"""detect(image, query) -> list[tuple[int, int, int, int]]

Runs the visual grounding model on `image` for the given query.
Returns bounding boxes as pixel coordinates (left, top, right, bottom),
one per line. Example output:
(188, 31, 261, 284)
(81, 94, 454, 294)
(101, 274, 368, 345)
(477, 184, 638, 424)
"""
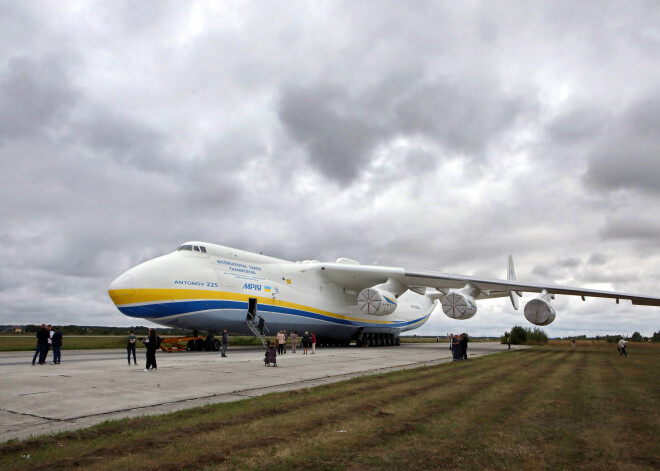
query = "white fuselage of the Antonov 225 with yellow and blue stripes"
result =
(109, 242, 436, 339)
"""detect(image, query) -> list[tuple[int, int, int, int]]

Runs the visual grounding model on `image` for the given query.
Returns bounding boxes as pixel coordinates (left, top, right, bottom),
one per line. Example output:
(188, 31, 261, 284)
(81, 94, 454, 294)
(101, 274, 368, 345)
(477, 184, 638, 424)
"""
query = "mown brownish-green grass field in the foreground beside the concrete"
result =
(0, 344, 660, 471)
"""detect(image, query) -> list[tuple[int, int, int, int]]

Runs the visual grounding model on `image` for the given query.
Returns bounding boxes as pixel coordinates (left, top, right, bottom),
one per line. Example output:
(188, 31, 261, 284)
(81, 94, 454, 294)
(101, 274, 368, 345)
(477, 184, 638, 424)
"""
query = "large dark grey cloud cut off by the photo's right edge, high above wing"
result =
(584, 88, 660, 194)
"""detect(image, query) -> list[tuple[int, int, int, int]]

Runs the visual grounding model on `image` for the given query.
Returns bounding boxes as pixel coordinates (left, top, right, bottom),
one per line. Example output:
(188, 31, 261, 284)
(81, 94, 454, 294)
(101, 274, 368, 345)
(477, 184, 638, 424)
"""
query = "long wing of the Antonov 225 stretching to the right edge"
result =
(320, 263, 660, 306)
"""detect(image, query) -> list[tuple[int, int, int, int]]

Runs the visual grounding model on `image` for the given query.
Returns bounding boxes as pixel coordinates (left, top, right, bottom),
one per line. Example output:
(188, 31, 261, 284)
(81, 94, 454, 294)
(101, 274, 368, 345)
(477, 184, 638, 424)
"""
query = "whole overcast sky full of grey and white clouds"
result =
(0, 0, 660, 336)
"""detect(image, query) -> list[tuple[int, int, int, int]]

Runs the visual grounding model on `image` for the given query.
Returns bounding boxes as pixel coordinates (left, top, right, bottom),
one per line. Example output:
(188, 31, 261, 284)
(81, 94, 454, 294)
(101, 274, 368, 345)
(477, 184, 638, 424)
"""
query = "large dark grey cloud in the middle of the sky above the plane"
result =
(278, 78, 536, 184)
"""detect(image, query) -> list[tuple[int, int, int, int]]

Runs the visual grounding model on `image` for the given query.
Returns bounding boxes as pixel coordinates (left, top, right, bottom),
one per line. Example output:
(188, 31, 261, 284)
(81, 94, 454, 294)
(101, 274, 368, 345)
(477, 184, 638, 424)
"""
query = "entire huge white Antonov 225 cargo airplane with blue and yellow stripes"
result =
(108, 241, 660, 346)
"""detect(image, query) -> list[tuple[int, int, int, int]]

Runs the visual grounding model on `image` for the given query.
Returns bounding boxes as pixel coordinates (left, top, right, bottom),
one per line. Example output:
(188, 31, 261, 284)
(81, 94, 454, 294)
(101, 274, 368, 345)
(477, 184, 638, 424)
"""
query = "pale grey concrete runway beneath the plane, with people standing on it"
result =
(0, 342, 521, 442)
